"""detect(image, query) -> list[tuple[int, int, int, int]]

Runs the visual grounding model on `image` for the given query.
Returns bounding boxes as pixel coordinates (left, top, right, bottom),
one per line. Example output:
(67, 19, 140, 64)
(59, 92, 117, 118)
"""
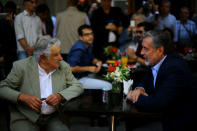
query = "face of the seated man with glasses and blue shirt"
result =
(79, 28, 94, 45)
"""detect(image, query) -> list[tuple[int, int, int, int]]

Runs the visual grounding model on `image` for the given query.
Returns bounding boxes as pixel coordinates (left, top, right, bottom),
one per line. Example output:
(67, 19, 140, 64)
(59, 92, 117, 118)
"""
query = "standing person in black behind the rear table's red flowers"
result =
(91, 0, 124, 61)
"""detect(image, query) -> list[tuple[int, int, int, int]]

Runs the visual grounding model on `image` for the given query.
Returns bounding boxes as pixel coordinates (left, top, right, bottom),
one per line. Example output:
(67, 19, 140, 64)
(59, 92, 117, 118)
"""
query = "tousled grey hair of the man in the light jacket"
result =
(33, 35, 61, 62)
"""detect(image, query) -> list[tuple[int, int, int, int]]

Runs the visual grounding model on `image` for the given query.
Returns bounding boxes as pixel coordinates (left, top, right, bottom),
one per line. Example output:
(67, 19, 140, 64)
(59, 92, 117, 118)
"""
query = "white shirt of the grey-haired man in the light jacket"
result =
(38, 64, 55, 115)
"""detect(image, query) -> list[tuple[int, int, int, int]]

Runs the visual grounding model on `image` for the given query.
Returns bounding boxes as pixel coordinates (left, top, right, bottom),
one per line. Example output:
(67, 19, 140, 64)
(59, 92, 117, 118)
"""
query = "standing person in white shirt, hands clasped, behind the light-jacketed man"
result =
(14, 0, 42, 59)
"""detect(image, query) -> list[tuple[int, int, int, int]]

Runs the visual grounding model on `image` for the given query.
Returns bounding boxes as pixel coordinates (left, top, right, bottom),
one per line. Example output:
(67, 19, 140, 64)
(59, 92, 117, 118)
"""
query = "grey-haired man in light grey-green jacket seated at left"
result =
(0, 36, 83, 131)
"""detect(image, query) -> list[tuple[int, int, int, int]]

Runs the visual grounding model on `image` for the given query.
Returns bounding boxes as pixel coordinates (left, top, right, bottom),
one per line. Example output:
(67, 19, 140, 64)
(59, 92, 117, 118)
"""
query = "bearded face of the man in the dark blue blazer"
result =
(141, 36, 164, 66)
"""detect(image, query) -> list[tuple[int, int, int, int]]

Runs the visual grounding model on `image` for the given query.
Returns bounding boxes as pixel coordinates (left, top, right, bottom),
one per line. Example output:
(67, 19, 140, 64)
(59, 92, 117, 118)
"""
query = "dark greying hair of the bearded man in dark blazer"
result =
(142, 31, 173, 55)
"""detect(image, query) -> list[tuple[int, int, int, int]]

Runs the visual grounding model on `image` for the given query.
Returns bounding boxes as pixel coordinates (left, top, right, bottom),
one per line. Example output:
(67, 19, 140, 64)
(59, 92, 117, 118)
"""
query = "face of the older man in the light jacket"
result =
(46, 45, 62, 69)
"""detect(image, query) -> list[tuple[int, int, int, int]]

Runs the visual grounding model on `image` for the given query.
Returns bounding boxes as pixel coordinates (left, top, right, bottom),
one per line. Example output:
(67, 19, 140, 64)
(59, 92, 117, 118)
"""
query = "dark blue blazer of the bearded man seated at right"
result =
(136, 53, 197, 131)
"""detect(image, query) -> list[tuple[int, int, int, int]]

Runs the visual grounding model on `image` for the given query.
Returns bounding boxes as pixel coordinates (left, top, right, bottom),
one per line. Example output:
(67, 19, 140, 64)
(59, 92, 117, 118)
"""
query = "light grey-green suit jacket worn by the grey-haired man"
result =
(0, 57, 83, 124)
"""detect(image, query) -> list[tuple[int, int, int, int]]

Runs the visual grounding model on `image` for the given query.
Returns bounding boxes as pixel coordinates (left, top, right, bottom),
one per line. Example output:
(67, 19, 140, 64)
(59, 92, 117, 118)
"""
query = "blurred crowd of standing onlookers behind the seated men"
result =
(0, 0, 197, 78)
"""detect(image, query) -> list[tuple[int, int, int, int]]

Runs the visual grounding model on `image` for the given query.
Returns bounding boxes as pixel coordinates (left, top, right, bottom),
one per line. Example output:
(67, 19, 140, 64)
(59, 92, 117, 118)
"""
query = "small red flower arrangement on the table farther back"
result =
(104, 46, 120, 60)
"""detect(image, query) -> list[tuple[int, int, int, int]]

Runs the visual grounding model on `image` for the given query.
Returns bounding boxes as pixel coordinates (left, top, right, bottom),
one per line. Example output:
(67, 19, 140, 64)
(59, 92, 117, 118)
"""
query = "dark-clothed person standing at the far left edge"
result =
(0, 1, 17, 76)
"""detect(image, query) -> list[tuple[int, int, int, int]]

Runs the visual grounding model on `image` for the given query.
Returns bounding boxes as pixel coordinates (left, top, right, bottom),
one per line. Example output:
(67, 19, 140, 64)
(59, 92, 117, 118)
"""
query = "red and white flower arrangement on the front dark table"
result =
(104, 61, 130, 92)
